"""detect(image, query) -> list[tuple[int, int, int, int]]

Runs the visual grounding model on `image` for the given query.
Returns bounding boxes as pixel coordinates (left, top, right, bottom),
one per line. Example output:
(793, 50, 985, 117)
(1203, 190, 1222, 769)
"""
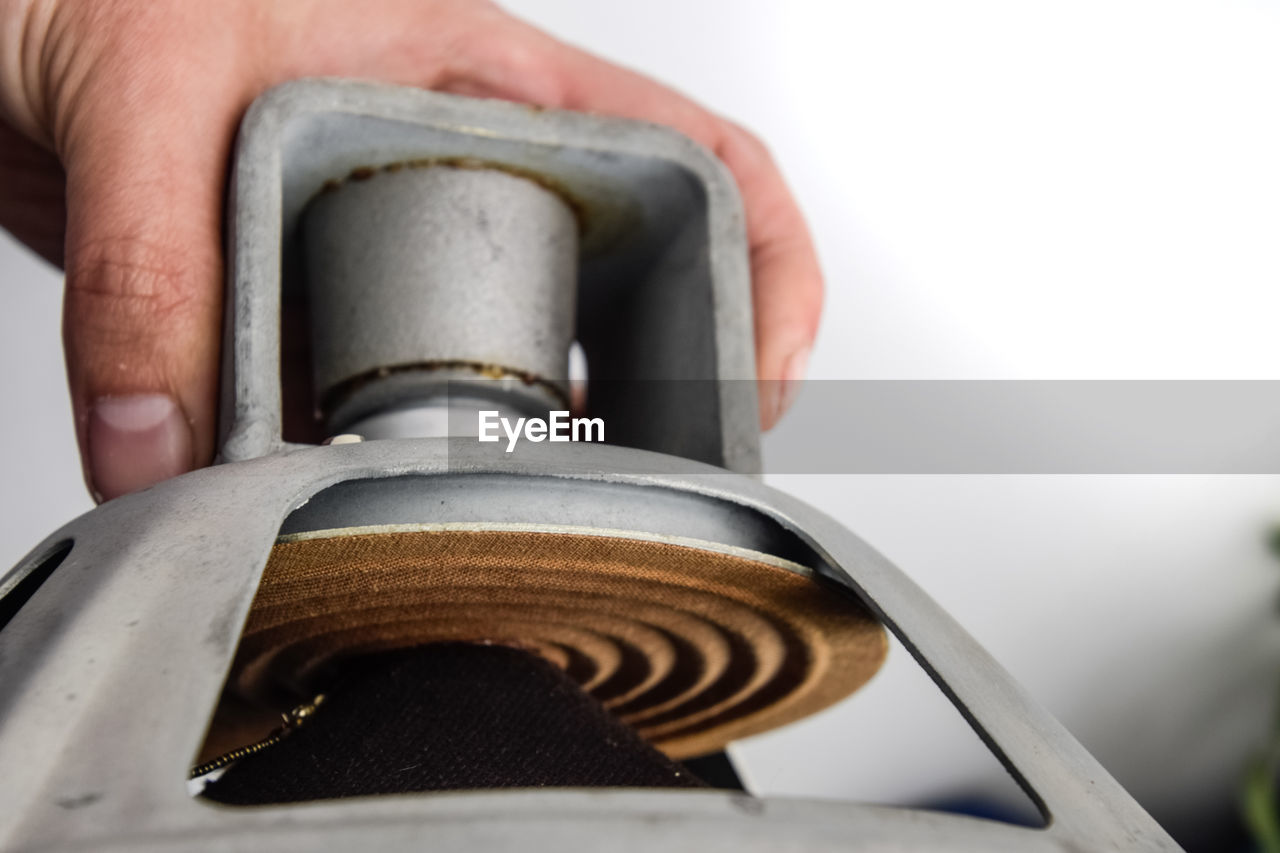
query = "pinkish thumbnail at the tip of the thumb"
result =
(88, 394, 191, 500)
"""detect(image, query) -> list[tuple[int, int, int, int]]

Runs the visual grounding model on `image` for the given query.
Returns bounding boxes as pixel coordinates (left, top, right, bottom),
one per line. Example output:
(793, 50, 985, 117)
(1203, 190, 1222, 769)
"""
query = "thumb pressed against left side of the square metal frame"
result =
(59, 80, 230, 500)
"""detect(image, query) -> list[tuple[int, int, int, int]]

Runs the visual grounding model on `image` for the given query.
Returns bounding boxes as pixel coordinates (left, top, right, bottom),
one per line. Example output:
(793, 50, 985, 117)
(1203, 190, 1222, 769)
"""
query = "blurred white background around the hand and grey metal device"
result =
(0, 0, 1280, 838)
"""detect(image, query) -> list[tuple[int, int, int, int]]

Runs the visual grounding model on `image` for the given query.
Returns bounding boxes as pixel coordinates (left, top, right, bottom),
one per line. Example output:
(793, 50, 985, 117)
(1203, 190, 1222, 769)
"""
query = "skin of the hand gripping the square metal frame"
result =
(0, 0, 823, 500)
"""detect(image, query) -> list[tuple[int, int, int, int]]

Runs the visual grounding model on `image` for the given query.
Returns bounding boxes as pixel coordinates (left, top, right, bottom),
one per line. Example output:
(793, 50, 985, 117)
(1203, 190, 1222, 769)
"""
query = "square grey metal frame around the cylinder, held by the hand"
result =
(220, 79, 759, 473)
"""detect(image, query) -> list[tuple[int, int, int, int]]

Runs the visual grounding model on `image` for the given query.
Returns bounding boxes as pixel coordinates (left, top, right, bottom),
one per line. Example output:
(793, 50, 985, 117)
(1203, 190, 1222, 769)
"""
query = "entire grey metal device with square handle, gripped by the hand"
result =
(0, 81, 1178, 852)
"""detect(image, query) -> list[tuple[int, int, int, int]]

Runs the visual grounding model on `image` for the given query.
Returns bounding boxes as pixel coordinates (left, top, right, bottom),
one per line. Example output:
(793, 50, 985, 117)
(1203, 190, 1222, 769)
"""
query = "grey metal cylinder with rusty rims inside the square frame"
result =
(302, 165, 577, 432)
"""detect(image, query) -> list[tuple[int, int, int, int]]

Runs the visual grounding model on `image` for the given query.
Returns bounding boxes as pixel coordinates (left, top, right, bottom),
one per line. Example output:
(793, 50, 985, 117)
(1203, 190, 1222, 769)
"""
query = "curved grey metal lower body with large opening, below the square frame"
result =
(0, 439, 1176, 850)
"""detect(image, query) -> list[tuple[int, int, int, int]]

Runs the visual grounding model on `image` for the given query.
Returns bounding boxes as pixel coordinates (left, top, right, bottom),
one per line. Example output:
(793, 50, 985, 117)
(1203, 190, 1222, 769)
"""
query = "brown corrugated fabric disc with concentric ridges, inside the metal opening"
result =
(220, 528, 886, 760)
